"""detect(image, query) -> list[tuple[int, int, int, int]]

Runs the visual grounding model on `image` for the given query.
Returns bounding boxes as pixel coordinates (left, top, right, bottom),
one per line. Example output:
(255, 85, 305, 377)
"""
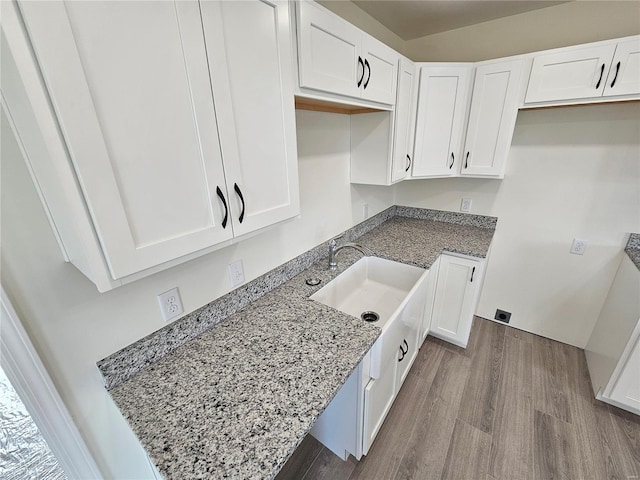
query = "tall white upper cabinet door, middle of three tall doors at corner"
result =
(411, 64, 473, 178)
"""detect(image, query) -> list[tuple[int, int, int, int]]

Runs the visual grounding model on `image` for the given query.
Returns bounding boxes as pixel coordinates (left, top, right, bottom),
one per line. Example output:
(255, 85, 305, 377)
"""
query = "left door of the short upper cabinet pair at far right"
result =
(525, 45, 615, 103)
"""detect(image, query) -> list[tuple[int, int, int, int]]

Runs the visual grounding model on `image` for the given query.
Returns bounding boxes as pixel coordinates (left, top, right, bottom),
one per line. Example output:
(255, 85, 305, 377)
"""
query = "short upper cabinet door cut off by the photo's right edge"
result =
(604, 38, 640, 97)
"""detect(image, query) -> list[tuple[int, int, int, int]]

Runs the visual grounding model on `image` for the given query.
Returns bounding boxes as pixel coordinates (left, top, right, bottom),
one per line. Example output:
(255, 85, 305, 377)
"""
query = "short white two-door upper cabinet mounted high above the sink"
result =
(296, 1, 400, 105)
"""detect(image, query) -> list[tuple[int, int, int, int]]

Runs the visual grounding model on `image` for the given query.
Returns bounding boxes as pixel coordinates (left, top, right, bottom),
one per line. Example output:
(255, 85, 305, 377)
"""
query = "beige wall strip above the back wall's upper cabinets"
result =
(404, 0, 640, 62)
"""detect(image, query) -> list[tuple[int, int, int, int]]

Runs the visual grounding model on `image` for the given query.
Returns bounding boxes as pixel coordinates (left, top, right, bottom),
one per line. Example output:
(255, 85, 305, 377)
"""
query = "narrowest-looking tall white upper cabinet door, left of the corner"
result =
(391, 59, 415, 183)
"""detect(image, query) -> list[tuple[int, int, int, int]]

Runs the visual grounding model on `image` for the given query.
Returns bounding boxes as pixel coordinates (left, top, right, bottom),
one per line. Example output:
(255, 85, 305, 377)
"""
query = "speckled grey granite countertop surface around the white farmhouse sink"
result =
(103, 207, 495, 480)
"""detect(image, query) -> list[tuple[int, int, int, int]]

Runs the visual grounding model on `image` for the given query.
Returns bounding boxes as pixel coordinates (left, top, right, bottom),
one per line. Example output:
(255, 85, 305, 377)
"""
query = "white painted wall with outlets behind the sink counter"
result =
(0, 111, 393, 478)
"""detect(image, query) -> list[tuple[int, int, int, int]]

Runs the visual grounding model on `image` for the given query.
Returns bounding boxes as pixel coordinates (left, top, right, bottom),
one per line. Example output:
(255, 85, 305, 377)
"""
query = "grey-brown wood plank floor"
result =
(276, 317, 640, 480)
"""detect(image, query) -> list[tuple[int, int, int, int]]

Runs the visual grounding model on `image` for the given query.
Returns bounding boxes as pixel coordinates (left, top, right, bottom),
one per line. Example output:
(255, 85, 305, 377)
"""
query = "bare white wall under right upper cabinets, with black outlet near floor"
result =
(396, 103, 640, 348)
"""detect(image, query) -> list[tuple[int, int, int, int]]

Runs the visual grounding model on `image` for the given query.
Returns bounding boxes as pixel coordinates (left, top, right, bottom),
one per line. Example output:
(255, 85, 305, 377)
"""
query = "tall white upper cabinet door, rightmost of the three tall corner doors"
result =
(460, 60, 524, 178)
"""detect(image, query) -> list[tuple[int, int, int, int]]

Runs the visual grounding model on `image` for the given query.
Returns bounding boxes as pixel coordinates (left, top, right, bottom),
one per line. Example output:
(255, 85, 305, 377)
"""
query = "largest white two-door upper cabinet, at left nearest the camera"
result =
(19, 0, 299, 291)
